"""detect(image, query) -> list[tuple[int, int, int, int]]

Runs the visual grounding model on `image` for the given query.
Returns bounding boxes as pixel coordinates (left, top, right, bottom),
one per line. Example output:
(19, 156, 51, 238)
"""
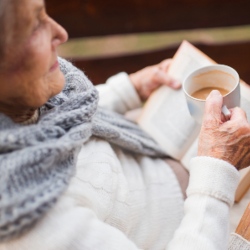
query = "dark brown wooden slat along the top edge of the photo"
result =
(46, 0, 250, 38)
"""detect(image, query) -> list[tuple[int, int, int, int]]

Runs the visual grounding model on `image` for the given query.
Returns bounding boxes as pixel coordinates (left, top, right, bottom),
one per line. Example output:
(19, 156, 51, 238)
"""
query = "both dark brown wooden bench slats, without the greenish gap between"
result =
(46, 0, 250, 84)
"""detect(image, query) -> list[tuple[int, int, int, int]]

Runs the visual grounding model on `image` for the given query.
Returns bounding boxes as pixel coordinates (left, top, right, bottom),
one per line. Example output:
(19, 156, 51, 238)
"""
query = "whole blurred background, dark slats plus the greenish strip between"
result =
(46, 0, 250, 84)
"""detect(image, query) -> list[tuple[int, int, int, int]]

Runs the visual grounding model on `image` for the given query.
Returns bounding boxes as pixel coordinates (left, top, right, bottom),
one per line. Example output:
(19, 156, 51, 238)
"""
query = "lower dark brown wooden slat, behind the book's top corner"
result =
(69, 41, 250, 84)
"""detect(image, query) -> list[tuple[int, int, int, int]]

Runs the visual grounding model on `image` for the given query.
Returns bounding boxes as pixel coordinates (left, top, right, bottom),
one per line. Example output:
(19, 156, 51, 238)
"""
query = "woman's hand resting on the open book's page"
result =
(130, 59, 181, 101)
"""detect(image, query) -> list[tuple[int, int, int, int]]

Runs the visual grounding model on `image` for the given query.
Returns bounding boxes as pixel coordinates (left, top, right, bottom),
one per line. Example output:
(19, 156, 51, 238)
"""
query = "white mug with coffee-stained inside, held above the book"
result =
(183, 64, 240, 123)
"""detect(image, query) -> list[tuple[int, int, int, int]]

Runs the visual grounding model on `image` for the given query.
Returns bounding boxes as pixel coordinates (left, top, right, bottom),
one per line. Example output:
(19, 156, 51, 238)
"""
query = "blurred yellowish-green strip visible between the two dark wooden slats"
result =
(59, 25, 250, 61)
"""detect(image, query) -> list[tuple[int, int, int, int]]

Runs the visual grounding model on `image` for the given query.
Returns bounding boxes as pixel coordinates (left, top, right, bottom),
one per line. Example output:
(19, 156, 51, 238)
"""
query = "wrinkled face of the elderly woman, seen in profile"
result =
(0, 0, 67, 111)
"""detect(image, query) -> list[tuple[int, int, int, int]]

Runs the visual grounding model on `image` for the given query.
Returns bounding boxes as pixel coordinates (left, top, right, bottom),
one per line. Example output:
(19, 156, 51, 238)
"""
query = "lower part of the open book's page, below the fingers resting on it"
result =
(138, 87, 200, 160)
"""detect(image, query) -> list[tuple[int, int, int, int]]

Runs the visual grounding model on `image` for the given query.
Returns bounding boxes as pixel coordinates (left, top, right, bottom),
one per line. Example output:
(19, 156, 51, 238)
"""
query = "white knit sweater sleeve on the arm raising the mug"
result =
(167, 157, 239, 250)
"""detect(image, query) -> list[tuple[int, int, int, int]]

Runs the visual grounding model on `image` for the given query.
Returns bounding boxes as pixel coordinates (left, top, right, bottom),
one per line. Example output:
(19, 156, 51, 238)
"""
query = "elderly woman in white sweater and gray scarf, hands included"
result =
(0, 0, 250, 250)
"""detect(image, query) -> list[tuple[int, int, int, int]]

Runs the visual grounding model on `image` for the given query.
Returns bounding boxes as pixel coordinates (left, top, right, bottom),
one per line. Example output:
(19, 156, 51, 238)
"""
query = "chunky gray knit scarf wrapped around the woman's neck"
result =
(0, 58, 165, 240)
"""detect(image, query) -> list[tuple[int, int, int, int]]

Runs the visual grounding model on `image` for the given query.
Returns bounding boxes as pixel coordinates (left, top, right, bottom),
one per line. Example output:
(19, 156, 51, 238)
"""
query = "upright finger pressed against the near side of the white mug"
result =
(204, 90, 223, 121)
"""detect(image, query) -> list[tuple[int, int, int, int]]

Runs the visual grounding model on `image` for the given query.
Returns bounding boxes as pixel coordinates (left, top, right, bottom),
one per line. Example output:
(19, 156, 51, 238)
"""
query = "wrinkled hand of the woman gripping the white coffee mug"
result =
(198, 90, 250, 170)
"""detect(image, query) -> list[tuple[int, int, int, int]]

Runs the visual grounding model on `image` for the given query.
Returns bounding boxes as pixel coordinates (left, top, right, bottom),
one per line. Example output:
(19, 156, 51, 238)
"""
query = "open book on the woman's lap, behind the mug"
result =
(137, 41, 250, 201)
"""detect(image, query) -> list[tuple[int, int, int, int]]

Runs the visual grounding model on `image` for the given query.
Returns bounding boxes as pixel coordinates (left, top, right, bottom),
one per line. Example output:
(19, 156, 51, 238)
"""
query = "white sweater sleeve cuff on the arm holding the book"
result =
(97, 72, 141, 114)
